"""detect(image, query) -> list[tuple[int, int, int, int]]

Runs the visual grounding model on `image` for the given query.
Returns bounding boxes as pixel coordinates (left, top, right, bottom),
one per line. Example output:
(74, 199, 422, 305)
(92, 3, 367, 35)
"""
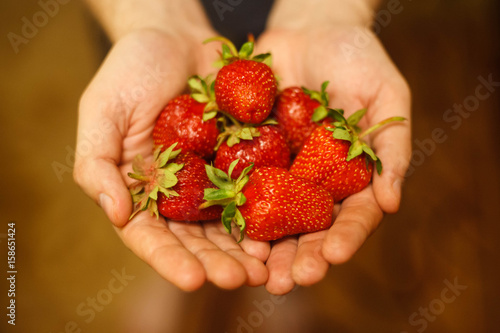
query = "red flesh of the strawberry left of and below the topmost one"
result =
(153, 95, 219, 158)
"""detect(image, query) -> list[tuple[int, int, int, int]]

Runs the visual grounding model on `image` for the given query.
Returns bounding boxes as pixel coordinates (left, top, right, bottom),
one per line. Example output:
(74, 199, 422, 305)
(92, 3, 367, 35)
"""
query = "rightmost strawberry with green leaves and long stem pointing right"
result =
(290, 109, 404, 202)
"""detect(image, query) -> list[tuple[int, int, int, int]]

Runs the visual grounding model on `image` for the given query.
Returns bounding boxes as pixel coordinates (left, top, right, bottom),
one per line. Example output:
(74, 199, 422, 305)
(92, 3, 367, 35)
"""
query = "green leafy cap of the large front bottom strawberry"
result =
(199, 159, 253, 243)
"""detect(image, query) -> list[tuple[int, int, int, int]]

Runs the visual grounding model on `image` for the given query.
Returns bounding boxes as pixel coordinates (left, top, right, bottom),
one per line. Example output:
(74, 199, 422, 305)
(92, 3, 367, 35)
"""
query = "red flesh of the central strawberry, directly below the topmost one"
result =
(214, 125, 290, 178)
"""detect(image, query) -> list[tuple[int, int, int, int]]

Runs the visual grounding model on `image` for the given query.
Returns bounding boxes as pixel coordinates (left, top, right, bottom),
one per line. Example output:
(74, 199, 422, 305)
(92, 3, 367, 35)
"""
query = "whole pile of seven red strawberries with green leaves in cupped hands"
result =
(129, 37, 404, 241)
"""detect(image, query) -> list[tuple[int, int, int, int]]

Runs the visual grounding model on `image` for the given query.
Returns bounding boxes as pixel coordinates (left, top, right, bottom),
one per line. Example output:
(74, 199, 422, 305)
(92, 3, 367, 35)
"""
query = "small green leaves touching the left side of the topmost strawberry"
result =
(188, 75, 219, 121)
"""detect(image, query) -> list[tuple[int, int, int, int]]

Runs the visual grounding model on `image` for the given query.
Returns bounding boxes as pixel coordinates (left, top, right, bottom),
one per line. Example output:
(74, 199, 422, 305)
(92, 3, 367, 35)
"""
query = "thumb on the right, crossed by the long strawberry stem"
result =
(369, 77, 411, 213)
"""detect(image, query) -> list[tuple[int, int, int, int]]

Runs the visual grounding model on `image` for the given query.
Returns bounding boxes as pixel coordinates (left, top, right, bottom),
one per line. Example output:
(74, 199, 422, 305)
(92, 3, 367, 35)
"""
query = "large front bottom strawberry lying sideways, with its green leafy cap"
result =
(201, 160, 333, 241)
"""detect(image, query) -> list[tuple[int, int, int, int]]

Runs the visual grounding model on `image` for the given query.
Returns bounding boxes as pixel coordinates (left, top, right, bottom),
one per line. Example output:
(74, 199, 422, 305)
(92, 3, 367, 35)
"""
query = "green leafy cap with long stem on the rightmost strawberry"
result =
(320, 109, 406, 174)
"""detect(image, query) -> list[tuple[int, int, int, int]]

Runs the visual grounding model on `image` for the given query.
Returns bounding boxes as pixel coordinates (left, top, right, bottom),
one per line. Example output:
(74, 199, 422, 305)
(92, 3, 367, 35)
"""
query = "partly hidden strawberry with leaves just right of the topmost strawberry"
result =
(275, 81, 328, 154)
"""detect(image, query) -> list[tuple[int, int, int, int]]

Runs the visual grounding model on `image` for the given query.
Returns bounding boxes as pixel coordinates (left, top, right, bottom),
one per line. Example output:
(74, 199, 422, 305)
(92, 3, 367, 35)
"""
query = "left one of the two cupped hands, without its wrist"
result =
(74, 29, 270, 290)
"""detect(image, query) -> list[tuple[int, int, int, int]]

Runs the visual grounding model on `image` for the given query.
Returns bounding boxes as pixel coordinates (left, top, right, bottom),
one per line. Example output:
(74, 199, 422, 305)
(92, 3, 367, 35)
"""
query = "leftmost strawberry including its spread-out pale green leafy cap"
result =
(128, 143, 222, 221)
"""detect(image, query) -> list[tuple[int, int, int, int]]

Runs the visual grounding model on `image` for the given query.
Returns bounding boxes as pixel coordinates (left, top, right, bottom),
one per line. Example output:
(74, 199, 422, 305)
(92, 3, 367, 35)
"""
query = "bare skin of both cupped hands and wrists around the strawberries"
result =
(74, 0, 411, 294)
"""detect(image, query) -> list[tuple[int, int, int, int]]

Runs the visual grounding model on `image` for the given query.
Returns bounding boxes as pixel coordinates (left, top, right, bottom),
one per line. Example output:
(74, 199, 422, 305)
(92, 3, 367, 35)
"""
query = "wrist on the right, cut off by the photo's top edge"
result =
(267, 0, 379, 30)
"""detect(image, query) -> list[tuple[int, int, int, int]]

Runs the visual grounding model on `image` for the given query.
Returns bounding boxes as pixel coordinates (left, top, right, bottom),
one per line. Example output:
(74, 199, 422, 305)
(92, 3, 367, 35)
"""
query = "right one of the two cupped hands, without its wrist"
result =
(257, 24, 411, 294)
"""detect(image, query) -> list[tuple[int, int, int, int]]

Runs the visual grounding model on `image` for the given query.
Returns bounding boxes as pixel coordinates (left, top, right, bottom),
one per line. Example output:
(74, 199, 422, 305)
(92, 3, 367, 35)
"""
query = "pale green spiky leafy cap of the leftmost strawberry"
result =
(128, 143, 184, 220)
